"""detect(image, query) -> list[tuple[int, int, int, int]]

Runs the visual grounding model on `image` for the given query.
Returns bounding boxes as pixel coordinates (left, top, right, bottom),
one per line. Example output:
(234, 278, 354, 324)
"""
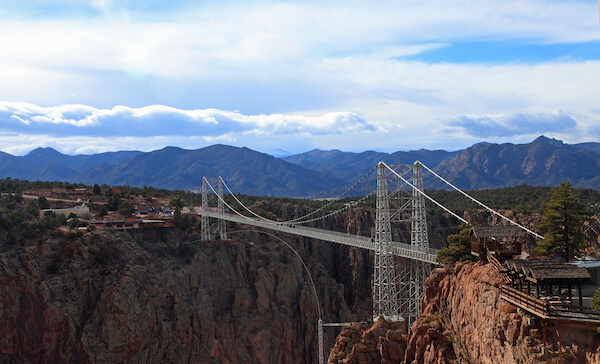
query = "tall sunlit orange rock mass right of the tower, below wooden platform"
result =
(422, 262, 597, 363)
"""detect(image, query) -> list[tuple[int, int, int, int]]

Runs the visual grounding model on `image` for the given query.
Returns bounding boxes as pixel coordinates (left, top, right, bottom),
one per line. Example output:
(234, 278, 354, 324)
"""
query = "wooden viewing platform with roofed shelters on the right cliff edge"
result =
(471, 226, 600, 329)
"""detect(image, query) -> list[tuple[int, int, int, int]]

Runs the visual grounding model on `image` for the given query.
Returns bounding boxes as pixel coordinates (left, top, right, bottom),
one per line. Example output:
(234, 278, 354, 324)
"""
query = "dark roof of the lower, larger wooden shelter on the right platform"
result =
(504, 259, 591, 281)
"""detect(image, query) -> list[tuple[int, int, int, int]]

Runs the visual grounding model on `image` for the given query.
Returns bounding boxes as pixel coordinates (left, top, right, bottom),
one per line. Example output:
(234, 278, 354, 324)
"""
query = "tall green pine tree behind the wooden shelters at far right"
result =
(535, 181, 591, 261)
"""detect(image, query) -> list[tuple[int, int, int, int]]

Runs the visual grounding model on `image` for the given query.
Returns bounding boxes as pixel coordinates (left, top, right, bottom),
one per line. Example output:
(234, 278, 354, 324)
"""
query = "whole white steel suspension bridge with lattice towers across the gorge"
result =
(198, 161, 448, 327)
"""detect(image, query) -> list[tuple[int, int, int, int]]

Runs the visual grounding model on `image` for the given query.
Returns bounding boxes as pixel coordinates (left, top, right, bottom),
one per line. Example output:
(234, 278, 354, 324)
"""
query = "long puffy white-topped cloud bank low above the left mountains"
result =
(0, 102, 377, 139)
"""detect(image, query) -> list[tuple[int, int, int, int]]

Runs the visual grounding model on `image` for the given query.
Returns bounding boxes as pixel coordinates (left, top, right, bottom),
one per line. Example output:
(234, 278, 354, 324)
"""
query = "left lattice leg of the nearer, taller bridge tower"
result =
(373, 163, 399, 321)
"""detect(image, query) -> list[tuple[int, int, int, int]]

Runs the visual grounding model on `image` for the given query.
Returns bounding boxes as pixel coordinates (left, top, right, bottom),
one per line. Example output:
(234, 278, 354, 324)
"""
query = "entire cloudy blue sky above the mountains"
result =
(0, 0, 600, 155)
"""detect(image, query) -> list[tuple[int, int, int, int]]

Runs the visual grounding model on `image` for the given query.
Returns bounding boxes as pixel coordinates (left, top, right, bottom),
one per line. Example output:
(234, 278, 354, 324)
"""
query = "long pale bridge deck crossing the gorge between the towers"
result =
(198, 211, 439, 264)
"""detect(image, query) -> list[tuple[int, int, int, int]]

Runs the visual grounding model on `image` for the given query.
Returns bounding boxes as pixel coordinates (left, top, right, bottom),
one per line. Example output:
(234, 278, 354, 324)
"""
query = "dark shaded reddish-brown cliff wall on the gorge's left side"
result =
(0, 230, 350, 363)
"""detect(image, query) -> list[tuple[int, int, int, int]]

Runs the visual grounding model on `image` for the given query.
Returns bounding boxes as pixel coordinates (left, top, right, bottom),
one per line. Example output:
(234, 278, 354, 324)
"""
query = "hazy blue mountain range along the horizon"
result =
(0, 136, 600, 197)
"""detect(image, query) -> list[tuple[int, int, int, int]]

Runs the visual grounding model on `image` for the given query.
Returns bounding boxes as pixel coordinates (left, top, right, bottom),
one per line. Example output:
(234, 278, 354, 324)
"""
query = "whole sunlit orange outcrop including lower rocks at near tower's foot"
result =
(329, 262, 600, 364)
